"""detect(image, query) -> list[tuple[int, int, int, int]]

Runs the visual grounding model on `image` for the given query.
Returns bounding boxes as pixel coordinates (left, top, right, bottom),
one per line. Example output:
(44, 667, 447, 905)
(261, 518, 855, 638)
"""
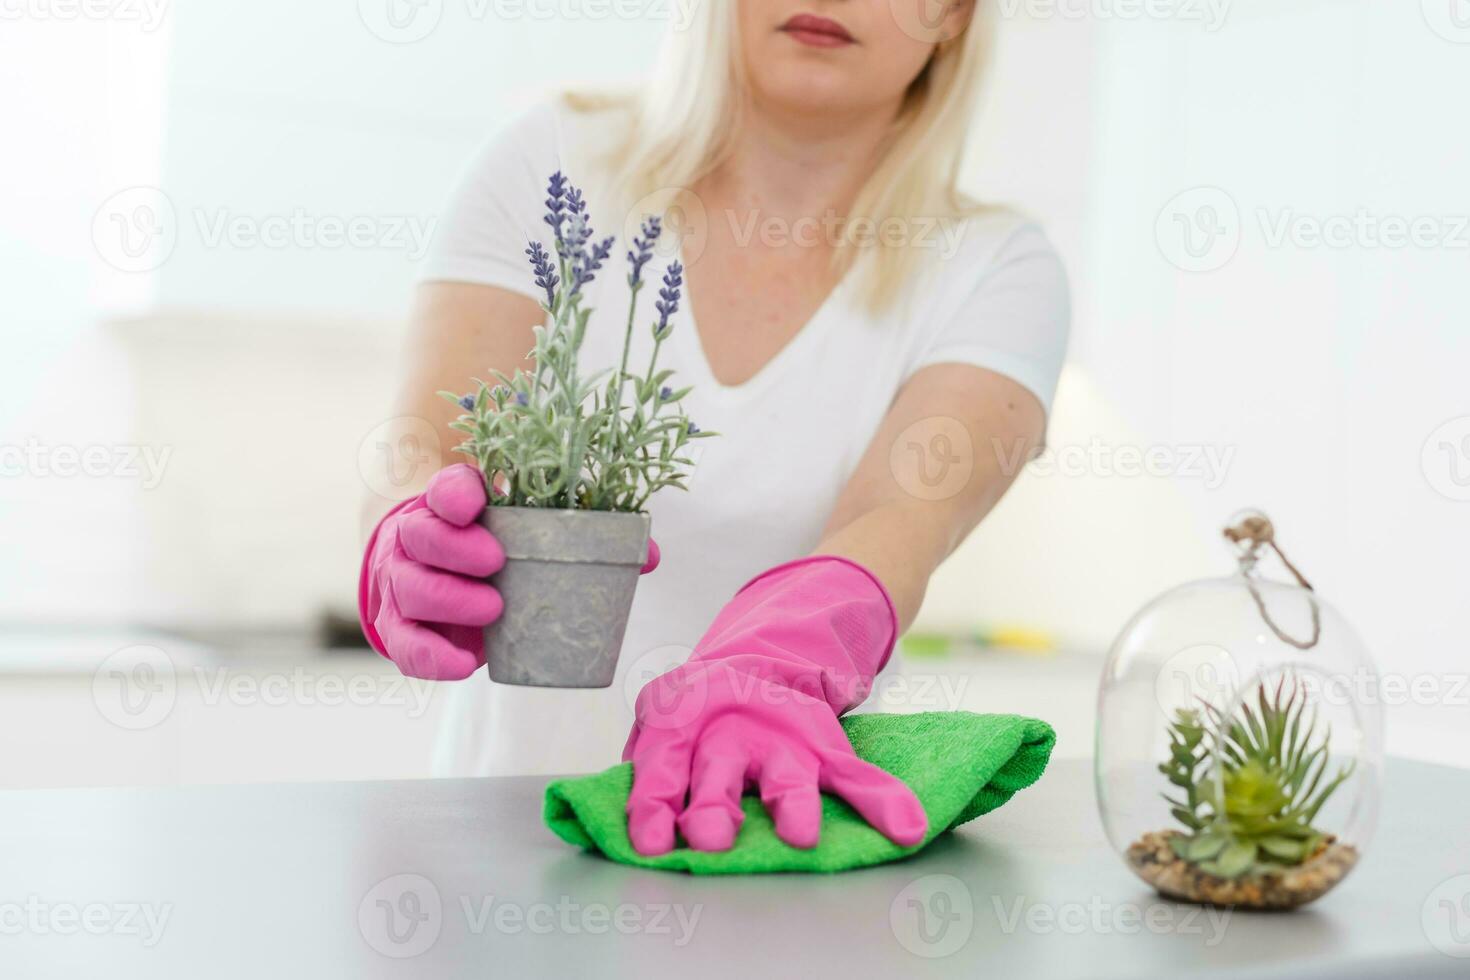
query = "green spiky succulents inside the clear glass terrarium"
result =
(1158, 677, 1354, 879)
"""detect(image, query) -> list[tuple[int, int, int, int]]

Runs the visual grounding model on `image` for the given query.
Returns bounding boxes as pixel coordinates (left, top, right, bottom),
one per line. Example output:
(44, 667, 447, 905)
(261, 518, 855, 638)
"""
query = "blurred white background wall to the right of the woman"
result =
(917, 0, 1470, 687)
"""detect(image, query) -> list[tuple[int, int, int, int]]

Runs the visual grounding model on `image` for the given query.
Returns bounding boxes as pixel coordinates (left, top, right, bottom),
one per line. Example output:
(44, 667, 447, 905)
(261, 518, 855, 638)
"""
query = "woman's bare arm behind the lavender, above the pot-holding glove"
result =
(363, 282, 544, 538)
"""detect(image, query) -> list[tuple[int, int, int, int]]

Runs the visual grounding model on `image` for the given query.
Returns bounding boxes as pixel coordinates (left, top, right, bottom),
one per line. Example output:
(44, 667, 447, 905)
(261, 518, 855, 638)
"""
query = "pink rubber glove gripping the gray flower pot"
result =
(357, 463, 659, 680)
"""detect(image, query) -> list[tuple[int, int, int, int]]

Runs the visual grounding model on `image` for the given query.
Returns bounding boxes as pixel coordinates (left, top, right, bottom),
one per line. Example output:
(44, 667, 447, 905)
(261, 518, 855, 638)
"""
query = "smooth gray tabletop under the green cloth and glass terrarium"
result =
(0, 761, 1470, 980)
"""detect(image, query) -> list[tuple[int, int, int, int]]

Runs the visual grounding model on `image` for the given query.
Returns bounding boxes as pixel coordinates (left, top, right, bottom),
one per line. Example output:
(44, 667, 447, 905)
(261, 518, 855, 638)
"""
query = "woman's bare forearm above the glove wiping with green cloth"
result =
(816, 364, 1045, 630)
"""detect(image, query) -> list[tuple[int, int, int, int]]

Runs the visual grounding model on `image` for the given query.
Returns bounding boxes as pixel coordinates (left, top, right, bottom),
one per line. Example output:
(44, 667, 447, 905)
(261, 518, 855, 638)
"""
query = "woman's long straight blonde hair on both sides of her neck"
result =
(567, 0, 994, 309)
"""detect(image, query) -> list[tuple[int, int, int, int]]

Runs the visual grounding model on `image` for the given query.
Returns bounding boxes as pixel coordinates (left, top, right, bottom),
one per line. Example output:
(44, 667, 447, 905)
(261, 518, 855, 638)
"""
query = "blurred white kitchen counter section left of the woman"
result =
(0, 629, 442, 789)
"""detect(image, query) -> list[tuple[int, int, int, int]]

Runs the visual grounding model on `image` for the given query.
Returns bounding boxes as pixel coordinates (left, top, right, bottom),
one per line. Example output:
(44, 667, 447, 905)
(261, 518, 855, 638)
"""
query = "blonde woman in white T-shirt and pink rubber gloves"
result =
(355, 0, 1069, 854)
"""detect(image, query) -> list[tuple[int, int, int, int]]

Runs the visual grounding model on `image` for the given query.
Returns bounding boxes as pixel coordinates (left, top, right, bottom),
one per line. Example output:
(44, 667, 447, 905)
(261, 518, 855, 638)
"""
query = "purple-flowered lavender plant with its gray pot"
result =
(440, 172, 711, 688)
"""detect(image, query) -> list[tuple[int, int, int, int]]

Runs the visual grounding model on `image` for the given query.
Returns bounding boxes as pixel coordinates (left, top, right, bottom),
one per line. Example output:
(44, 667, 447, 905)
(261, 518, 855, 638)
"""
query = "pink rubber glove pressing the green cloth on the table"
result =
(623, 557, 928, 854)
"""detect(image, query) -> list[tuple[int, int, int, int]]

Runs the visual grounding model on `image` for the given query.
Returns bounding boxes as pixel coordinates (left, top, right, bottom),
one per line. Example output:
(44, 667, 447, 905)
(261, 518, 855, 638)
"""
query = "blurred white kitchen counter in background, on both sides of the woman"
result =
(0, 630, 1470, 789)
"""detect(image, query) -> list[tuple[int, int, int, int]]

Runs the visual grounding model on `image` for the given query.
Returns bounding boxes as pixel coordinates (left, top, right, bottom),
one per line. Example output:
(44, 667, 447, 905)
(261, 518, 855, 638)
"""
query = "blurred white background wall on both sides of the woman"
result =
(0, 0, 1470, 758)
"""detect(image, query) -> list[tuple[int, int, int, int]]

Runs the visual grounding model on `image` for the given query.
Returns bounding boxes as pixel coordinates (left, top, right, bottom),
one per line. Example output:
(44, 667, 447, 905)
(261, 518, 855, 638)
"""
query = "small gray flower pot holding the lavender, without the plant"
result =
(479, 507, 648, 688)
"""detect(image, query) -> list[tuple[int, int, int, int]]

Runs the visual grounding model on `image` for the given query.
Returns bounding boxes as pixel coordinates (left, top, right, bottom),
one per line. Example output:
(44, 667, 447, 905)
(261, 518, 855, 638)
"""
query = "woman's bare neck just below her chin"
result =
(700, 91, 898, 219)
